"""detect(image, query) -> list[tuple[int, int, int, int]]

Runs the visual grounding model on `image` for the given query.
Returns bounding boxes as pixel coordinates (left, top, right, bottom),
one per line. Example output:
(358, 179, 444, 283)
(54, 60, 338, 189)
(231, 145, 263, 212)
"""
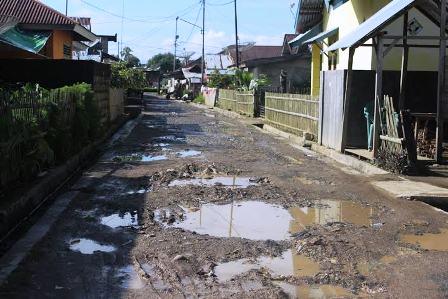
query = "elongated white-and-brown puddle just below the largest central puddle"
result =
(215, 250, 320, 282)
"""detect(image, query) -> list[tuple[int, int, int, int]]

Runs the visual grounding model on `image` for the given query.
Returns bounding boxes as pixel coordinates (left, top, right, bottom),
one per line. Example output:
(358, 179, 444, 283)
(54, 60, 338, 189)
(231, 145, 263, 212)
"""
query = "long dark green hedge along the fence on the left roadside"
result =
(0, 83, 101, 190)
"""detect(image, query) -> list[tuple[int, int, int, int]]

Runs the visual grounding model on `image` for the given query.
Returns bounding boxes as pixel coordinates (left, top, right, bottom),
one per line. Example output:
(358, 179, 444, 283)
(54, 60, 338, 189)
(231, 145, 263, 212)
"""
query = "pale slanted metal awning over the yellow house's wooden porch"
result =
(326, 0, 417, 52)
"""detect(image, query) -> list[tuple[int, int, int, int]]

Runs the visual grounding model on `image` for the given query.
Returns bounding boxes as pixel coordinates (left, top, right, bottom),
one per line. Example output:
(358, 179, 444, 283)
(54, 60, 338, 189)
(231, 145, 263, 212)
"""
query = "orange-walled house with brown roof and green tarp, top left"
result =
(0, 0, 97, 59)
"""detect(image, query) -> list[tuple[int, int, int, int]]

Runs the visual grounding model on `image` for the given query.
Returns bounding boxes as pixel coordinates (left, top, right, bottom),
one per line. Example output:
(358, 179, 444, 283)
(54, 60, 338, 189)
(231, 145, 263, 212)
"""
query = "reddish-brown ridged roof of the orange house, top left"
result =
(0, 0, 78, 25)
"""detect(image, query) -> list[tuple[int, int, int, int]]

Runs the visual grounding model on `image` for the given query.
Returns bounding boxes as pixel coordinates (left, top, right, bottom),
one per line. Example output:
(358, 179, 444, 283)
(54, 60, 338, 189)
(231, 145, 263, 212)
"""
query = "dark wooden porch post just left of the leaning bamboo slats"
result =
(373, 35, 384, 158)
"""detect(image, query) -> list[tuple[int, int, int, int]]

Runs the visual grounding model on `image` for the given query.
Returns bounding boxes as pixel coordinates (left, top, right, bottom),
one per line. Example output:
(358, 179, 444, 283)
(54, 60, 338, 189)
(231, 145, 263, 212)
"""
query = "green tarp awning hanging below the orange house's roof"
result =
(0, 27, 50, 54)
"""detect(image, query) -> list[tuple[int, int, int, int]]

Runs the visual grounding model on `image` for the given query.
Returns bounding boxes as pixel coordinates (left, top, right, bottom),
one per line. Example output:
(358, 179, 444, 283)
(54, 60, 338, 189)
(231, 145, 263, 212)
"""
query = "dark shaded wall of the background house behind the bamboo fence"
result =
(249, 57, 311, 88)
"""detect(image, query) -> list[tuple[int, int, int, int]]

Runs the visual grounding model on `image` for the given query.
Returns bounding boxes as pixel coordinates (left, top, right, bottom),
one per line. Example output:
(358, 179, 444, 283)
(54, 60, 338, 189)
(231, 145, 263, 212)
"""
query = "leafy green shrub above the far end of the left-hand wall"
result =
(111, 61, 148, 89)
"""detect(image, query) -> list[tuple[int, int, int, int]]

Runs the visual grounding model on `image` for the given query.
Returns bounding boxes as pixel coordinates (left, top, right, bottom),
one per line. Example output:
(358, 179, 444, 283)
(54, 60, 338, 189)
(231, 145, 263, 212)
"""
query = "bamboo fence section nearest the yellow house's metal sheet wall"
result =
(265, 92, 319, 140)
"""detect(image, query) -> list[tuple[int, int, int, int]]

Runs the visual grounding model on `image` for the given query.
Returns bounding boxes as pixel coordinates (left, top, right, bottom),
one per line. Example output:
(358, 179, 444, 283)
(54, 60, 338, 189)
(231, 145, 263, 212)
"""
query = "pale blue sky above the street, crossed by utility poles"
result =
(42, 0, 297, 62)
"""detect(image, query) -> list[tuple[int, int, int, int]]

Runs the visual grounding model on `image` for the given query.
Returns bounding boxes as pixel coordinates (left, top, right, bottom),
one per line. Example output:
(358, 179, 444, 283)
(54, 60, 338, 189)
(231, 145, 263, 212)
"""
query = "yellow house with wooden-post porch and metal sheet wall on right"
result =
(290, 0, 448, 161)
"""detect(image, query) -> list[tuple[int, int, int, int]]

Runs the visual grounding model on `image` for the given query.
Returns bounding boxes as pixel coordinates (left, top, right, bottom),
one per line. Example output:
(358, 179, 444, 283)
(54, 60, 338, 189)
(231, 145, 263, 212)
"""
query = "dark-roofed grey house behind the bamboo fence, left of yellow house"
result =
(222, 43, 310, 90)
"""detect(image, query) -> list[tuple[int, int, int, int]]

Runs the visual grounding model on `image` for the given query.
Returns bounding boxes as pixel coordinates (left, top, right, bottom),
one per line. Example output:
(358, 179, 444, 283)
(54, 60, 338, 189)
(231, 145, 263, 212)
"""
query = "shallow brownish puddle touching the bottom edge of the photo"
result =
(275, 282, 353, 299)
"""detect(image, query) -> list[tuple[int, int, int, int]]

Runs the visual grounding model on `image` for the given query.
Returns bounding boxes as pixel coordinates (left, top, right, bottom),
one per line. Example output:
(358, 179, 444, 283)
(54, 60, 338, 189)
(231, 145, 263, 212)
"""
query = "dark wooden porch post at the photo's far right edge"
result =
(436, 0, 448, 163)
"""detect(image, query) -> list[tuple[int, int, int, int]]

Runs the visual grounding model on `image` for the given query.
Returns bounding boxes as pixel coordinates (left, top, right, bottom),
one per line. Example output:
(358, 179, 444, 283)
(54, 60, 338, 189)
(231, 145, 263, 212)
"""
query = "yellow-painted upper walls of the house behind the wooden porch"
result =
(291, 0, 439, 96)
